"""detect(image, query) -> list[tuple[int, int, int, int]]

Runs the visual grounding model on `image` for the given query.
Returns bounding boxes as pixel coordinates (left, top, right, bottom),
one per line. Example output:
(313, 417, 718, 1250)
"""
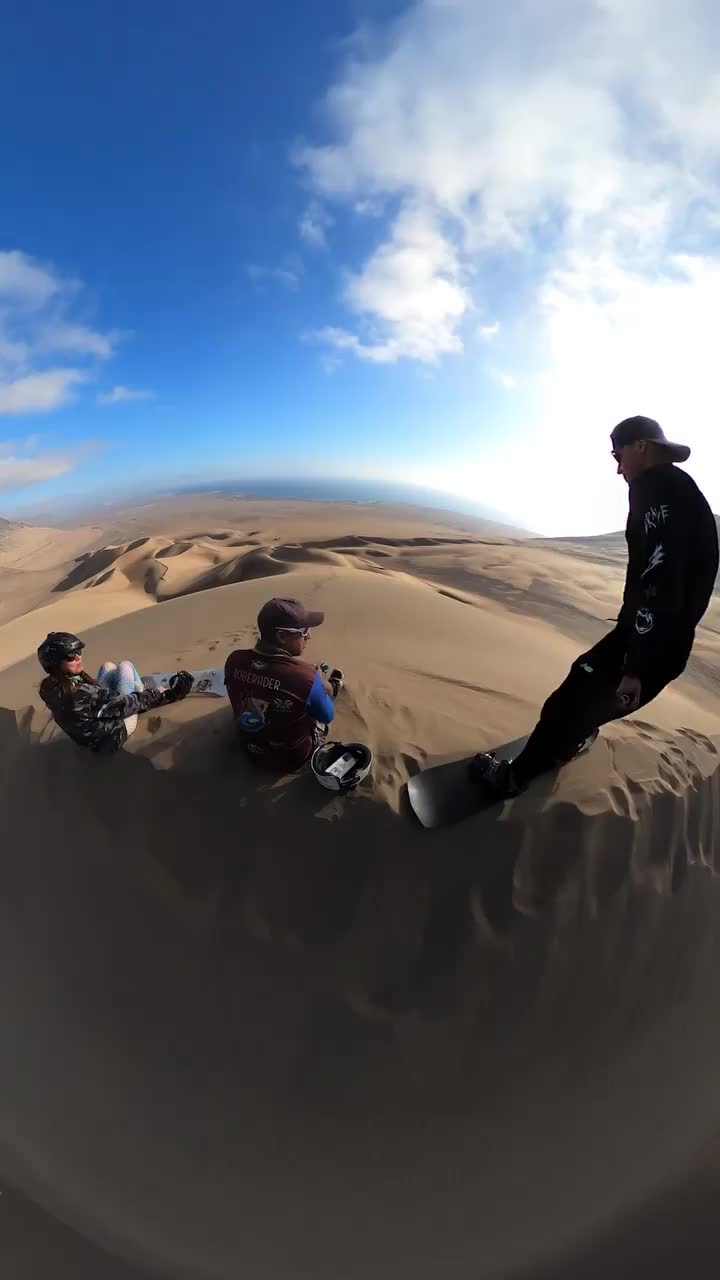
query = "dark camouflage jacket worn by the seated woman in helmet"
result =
(40, 676, 165, 755)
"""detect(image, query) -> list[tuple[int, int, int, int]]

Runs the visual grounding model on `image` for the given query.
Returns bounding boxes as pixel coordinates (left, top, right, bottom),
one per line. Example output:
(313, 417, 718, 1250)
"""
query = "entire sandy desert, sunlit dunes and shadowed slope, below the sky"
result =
(0, 494, 720, 1280)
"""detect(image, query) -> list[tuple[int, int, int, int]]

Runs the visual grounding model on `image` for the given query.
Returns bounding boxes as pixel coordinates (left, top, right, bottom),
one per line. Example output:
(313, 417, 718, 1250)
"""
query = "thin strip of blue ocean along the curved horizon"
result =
(167, 479, 523, 529)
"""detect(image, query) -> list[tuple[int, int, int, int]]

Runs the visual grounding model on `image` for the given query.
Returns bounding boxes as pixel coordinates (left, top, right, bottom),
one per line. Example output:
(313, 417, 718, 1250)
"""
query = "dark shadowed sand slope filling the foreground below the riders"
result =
(0, 713, 720, 1277)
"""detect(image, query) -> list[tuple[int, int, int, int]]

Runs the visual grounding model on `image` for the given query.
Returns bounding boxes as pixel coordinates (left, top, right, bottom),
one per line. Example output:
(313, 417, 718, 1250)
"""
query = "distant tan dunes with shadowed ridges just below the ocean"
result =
(0, 494, 517, 625)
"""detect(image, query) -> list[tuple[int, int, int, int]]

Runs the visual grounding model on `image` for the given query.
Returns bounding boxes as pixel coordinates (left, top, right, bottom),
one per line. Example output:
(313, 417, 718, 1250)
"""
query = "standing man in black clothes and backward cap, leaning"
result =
(470, 416, 717, 800)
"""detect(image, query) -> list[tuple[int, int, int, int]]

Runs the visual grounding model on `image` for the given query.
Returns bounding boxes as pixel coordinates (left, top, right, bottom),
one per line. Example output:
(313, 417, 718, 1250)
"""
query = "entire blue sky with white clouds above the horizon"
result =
(0, 0, 720, 534)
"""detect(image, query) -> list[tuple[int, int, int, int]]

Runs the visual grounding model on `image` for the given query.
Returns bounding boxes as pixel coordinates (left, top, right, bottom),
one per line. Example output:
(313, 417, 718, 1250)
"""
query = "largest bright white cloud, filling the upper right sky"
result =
(296, 0, 720, 527)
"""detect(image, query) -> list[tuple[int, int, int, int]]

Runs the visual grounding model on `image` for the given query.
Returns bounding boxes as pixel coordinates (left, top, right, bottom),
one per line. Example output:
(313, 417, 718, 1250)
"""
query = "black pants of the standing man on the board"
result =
(512, 628, 689, 787)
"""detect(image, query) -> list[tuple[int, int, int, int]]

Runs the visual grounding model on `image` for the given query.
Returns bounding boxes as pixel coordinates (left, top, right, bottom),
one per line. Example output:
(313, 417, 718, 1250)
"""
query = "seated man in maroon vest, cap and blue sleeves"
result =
(225, 599, 342, 771)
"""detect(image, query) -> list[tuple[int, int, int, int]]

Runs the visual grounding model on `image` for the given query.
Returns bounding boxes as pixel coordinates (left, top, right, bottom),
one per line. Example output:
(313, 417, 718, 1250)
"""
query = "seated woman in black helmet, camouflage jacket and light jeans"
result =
(37, 631, 192, 755)
